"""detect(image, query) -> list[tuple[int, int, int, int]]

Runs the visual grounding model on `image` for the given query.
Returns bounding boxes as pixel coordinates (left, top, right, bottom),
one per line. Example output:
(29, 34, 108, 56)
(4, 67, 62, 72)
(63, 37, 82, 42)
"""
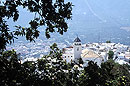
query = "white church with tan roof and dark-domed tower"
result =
(62, 37, 103, 65)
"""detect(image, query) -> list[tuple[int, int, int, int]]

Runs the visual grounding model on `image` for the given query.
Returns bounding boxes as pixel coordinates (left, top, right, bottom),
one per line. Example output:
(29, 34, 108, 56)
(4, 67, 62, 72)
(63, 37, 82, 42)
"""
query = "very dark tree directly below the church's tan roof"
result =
(84, 61, 104, 86)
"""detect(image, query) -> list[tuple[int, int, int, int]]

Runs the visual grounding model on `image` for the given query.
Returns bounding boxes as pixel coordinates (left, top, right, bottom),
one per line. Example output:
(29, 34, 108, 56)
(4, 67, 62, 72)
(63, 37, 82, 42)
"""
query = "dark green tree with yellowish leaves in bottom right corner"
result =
(101, 59, 130, 86)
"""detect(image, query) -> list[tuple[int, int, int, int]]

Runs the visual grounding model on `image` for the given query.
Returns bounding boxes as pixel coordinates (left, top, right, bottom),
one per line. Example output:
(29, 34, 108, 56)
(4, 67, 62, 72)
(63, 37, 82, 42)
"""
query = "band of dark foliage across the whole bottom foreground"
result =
(0, 44, 130, 86)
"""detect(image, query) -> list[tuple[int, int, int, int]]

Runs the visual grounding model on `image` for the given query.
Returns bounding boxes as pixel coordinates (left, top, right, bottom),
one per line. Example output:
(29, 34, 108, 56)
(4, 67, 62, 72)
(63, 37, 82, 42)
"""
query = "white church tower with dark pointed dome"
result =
(73, 37, 82, 60)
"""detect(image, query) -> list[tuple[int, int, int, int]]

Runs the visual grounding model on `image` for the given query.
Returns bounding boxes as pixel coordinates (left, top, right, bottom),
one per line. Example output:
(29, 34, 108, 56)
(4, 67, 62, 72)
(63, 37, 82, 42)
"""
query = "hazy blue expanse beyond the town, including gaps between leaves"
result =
(9, 0, 130, 45)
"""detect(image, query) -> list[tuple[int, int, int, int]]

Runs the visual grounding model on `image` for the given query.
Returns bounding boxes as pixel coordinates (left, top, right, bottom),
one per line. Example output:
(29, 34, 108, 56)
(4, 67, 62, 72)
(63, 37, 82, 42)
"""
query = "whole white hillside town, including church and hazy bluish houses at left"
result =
(7, 37, 130, 66)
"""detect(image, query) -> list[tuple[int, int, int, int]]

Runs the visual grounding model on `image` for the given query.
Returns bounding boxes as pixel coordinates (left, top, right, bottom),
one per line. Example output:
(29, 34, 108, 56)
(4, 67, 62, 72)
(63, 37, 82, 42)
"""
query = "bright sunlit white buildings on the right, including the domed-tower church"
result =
(62, 37, 130, 66)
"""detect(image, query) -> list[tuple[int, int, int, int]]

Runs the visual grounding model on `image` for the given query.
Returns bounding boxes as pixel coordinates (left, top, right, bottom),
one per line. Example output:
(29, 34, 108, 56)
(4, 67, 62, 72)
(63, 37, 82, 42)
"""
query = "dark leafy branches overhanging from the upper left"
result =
(0, 0, 72, 50)
